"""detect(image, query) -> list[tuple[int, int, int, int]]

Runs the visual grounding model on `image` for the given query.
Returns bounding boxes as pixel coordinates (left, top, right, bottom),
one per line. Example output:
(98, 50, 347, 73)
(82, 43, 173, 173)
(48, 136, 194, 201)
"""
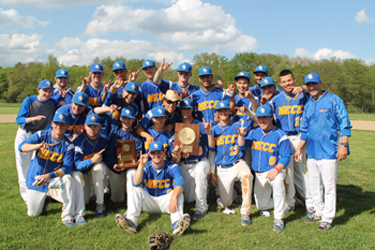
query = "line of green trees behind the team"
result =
(0, 53, 375, 112)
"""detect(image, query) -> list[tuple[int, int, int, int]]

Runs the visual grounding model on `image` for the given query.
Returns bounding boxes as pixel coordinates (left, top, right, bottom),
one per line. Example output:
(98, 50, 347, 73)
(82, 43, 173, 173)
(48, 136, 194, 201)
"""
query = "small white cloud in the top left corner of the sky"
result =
(0, 8, 49, 28)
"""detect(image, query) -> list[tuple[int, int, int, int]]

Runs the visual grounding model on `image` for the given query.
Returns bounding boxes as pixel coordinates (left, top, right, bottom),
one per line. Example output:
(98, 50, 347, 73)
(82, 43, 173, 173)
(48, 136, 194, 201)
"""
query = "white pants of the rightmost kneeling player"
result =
(254, 169, 285, 220)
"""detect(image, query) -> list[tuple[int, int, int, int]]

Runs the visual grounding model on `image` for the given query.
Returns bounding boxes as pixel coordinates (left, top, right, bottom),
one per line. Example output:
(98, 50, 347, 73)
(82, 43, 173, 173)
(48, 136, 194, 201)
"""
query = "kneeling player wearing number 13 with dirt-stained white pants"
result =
(207, 101, 253, 226)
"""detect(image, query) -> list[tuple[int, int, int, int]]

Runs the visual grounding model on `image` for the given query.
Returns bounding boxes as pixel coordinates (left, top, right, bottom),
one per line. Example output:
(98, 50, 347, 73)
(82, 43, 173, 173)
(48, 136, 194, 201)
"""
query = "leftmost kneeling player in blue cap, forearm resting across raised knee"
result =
(18, 112, 74, 227)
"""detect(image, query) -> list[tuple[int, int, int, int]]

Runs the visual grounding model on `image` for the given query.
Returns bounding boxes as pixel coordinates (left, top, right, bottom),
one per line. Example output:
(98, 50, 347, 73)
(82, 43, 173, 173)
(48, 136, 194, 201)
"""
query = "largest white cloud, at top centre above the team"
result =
(84, 0, 258, 52)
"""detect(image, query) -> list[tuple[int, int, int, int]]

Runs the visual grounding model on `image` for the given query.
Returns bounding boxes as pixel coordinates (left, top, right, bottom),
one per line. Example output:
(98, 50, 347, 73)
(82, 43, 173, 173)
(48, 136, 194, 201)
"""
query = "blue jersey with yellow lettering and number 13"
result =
(210, 122, 250, 165)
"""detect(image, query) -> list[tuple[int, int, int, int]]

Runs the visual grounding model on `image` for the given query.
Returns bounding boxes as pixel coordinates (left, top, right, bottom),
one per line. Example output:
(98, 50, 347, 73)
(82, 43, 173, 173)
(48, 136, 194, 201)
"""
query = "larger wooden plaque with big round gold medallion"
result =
(174, 122, 201, 156)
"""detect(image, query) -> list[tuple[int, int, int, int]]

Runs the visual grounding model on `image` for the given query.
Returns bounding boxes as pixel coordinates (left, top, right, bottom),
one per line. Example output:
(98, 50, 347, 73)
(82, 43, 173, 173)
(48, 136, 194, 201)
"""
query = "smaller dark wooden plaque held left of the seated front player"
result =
(116, 139, 138, 169)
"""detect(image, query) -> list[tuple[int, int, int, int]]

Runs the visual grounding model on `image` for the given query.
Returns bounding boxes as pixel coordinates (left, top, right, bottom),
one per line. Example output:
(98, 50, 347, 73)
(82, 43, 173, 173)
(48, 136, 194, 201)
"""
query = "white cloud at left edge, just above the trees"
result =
(0, 34, 48, 66)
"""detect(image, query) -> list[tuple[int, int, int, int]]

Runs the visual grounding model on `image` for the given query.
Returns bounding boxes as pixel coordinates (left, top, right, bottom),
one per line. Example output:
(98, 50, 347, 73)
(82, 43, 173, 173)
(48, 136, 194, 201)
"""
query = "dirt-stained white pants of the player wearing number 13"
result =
(217, 160, 253, 215)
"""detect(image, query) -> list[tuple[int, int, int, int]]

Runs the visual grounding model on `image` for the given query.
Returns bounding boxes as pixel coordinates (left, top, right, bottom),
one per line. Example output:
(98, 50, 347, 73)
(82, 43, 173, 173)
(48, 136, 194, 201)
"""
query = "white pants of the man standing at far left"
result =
(14, 128, 34, 203)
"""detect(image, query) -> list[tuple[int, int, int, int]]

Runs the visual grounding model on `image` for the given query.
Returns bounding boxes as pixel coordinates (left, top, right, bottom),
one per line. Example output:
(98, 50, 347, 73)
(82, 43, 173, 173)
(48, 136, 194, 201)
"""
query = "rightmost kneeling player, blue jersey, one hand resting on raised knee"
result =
(238, 104, 292, 231)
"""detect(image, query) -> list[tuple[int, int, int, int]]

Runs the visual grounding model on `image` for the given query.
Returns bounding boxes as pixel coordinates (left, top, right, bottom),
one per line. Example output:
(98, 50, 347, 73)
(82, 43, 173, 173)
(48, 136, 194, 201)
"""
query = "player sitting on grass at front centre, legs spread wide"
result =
(116, 141, 190, 235)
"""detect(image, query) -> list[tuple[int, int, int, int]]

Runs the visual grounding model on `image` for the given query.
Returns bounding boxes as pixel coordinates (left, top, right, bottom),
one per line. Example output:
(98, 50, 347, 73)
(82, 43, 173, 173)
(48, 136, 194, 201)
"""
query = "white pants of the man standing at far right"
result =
(307, 159, 338, 223)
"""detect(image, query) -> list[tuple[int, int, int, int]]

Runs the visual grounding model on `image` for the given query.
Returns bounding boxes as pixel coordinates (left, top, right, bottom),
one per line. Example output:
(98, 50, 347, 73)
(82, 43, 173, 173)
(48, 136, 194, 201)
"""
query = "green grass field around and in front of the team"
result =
(0, 124, 375, 249)
